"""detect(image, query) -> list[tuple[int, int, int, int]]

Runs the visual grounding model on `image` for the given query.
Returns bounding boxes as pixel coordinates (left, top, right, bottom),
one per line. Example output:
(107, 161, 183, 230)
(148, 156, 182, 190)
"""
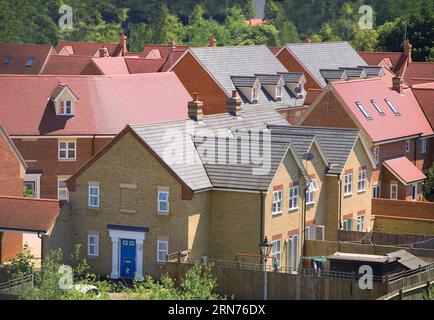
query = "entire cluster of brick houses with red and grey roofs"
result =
(0, 36, 434, 279)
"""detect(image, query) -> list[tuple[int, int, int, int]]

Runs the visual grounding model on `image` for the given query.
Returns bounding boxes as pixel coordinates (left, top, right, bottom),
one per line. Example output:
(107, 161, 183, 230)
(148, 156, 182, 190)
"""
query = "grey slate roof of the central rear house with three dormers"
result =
(189, 45, 304, 109)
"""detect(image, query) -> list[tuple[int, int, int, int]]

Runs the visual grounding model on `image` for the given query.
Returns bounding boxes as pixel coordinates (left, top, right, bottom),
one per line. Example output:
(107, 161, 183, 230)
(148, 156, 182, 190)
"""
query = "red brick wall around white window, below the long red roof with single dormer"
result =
(14, 138, 110, 199)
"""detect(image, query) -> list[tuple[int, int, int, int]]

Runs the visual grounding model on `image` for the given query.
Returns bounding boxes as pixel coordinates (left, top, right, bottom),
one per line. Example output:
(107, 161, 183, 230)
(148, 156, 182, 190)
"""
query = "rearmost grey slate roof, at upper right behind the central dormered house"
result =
(284, 41, 366, 87)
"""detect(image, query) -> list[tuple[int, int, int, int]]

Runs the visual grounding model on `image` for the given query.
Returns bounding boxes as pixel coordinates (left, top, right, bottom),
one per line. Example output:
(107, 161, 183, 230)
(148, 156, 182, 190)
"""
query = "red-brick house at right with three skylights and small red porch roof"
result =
(301, 78, 434, 200)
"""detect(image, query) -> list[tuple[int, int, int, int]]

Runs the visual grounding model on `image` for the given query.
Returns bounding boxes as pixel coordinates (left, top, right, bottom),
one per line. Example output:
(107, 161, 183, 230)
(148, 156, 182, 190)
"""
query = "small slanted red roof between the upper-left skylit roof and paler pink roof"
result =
(41, 55, 90, 75)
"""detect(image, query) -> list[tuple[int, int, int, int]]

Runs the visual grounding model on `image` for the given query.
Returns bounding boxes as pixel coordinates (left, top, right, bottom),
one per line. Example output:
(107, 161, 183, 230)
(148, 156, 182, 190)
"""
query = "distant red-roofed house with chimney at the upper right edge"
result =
(359, 41, 434, 85)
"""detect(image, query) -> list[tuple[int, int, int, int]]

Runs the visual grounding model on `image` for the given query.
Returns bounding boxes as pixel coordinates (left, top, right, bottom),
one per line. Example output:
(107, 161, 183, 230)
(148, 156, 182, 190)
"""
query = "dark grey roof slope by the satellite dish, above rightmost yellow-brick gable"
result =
(268, 126, 360, 174)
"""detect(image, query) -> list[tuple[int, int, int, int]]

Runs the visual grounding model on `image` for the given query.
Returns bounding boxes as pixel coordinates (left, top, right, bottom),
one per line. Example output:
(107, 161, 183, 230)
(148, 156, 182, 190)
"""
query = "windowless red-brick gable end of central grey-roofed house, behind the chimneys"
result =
(173, 53, 228, 114)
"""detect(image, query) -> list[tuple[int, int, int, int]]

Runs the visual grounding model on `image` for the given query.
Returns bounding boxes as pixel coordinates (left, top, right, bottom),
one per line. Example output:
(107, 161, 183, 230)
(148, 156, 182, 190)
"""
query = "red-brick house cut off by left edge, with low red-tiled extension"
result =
(0, 124, 60, 264)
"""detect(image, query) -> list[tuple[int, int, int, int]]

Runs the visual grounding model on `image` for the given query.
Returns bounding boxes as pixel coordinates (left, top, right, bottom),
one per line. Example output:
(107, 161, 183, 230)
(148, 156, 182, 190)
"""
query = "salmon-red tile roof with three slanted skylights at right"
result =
(331, 78, 433, 142)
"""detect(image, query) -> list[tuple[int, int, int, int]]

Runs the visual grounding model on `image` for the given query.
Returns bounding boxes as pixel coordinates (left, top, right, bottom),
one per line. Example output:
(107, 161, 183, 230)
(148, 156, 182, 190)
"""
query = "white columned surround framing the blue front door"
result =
(108, 225, 148, 280)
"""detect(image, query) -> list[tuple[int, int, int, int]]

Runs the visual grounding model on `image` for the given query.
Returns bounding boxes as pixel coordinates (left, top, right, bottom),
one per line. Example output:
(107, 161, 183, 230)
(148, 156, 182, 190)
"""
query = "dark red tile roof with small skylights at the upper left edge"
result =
(0, 44, 55, 74)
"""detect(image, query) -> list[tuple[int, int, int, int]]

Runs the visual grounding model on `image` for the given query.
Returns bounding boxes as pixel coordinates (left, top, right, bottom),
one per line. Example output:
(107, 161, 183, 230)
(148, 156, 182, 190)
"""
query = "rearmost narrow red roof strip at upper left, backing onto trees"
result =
(56, 40, 120, 57)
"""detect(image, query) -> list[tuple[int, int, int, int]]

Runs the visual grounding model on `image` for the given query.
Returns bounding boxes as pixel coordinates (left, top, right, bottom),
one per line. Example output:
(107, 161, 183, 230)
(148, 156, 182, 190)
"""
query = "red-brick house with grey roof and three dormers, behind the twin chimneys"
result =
(170, 45, 306, 123)
